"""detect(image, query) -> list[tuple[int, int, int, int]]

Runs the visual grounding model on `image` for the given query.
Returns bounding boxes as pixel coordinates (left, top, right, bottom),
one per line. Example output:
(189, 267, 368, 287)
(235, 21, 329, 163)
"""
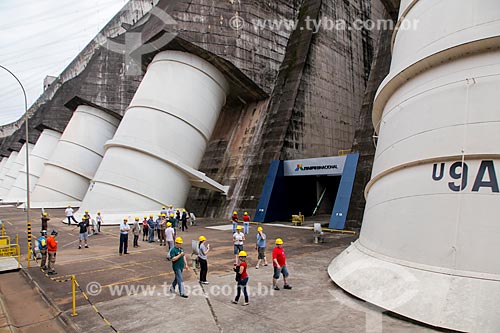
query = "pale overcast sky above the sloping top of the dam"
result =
(0, 0, 127, 125)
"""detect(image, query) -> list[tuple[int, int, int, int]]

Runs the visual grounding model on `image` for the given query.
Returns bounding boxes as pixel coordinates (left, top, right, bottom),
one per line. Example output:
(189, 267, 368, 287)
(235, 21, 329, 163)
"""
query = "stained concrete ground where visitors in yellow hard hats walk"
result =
(0, 207, 442, 333)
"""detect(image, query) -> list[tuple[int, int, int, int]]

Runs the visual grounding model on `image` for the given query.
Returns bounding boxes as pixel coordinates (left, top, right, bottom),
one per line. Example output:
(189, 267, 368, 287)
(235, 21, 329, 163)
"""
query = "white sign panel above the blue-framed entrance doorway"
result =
(284, 156, 346, 176)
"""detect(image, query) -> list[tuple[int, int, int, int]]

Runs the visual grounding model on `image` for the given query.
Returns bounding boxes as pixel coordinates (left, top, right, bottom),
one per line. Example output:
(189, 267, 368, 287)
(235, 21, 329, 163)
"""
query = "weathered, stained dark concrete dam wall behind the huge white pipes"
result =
(0, 0, 389, 223)
